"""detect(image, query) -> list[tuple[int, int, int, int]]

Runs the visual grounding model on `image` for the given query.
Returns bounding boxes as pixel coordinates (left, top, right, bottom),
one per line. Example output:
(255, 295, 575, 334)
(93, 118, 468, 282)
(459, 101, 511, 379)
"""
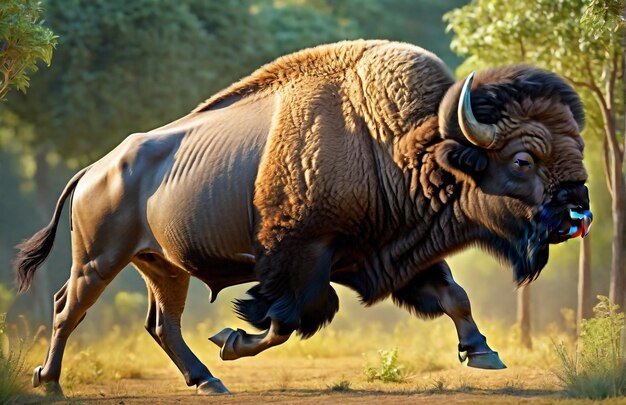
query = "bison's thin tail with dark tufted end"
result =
(13, 167, 89, 293)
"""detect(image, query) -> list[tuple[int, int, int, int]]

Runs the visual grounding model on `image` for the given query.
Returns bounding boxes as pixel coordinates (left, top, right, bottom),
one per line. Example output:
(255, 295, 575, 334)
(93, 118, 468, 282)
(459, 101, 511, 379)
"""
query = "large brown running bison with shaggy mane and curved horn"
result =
(16, 41, 591, 393)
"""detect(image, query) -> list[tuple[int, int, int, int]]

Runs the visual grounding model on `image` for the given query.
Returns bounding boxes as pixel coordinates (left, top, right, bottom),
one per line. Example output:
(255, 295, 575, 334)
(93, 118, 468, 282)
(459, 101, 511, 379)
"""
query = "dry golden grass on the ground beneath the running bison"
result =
(0, 296, 616, 403)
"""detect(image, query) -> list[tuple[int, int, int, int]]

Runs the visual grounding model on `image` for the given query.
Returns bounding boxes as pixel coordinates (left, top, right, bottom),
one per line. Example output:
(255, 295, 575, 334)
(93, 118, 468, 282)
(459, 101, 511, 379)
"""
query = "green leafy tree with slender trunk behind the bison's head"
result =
(446, 0, 626, 340)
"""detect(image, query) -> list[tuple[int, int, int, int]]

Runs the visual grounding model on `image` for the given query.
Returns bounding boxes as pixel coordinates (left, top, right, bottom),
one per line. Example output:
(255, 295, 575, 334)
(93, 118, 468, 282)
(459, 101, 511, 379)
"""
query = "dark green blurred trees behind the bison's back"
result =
(0, 0, 366, 319)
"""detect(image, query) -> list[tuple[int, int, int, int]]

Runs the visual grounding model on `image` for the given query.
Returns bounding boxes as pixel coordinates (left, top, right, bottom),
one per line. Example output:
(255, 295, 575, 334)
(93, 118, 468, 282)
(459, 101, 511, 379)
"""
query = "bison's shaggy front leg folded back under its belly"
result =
(210, 238, 339, 360)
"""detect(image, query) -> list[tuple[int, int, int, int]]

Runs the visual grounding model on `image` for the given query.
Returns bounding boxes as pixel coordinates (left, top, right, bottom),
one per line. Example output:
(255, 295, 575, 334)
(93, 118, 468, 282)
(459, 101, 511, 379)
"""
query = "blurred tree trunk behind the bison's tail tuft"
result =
(30, 151, 54, 323)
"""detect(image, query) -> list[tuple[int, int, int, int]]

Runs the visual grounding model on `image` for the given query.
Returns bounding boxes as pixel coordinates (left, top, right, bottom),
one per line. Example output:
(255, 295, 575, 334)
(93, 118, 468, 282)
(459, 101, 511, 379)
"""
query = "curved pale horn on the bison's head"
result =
(458, 72, 498, 149)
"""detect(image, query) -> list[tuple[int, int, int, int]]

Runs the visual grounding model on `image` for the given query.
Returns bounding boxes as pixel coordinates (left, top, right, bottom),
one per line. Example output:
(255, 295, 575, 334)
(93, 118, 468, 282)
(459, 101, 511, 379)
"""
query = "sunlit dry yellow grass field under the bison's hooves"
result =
(7, 308, 626, 404)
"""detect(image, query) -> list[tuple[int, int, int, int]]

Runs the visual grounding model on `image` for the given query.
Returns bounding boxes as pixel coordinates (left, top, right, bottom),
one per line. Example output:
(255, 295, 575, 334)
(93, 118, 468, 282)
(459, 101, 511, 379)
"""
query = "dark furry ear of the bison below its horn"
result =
(435, 139, 488, 182)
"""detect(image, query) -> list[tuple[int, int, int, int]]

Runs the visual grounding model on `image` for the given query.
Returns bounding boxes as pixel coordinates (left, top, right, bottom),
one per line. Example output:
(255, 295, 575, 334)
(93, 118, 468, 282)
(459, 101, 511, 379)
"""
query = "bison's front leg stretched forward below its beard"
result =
(393, 261, 506, 369)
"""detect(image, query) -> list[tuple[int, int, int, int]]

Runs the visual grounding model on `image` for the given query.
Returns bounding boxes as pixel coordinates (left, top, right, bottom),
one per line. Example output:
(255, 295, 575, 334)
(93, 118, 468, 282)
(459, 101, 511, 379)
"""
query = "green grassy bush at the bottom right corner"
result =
(556, 296, 626, 399)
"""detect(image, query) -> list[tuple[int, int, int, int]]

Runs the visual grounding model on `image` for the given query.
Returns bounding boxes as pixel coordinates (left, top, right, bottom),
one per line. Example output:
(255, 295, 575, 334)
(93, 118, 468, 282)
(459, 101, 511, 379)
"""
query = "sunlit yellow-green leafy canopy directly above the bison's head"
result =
(444, 0, 623, 135)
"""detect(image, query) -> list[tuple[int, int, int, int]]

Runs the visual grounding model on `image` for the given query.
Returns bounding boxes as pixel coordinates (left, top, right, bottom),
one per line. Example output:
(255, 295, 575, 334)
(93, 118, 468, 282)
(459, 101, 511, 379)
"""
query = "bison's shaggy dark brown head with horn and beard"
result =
(437, 66, 592, 283)
